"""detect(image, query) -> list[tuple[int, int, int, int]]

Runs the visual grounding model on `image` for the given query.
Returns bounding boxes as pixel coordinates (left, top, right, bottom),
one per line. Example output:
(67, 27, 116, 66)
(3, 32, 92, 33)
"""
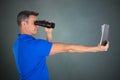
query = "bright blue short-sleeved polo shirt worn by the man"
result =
(13, 34, 52, 80)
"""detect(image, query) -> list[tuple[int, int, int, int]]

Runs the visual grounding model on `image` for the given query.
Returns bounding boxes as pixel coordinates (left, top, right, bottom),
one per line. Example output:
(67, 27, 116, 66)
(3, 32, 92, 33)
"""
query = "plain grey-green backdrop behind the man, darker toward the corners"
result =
(0, 0, 120, 80)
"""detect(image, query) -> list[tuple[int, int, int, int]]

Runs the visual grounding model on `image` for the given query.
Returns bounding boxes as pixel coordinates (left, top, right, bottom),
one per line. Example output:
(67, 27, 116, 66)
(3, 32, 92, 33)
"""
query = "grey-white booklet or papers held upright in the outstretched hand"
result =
(100, 24, 109, 46)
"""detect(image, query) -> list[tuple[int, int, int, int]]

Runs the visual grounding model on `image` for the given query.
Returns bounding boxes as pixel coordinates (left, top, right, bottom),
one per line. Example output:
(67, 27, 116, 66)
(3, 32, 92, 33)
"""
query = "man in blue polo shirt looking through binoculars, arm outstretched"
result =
(14, 11, 109, 80)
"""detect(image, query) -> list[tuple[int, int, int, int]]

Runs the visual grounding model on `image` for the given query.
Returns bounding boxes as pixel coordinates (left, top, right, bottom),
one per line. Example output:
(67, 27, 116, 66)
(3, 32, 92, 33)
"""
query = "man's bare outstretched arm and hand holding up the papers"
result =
(50, 42, 109, 55)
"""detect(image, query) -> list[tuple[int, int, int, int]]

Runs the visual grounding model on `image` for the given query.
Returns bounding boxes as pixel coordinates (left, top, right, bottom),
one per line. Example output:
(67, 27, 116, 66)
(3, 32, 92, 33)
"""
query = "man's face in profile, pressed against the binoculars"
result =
(26, 15, 38, 35)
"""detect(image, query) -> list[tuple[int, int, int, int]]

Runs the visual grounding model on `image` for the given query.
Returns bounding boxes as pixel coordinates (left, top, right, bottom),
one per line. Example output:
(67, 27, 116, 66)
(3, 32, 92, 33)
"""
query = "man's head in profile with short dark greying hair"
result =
(17, 11, 38, 35)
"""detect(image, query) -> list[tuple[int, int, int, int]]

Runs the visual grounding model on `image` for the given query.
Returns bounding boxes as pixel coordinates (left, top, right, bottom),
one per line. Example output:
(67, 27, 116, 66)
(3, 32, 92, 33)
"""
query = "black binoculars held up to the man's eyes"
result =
(34, 20, 55, 28)
